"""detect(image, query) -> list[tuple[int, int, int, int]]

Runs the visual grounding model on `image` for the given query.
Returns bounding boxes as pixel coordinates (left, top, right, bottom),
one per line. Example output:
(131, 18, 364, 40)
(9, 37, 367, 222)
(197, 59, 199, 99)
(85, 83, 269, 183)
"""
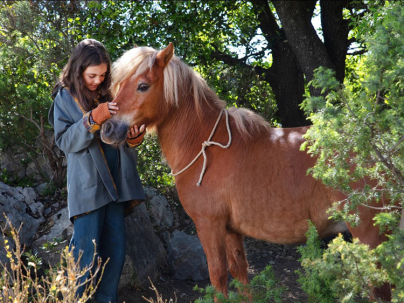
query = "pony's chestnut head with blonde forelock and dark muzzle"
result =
(101, 43, 174, 145)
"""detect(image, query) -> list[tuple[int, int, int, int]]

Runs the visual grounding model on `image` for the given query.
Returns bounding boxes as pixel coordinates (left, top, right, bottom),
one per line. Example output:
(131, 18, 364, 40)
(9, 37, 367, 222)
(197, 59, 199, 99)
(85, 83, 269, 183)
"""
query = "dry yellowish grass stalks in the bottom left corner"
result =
(0, 215, 105, 303)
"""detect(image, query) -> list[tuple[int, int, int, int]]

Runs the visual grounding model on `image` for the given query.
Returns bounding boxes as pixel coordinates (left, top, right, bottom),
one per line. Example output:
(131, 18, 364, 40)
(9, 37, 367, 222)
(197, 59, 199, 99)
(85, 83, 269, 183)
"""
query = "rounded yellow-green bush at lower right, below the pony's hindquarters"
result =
(302, 235, 389, 303)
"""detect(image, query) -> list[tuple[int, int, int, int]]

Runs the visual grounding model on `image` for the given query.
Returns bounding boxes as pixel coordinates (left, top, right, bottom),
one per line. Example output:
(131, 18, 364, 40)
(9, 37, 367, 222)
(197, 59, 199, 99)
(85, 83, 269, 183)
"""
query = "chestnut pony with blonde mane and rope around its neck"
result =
(101, 43, 388, 302)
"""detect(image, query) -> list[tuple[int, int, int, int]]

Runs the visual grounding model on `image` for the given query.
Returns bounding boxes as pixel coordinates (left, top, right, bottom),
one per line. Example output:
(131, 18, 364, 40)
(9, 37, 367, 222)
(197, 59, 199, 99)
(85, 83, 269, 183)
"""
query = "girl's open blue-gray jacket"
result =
(49, 88, 145, 218)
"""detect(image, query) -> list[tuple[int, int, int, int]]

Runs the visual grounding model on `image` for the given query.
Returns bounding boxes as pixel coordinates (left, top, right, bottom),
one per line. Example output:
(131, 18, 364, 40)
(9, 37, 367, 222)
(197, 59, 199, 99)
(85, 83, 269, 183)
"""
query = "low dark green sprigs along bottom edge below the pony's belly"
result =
(195, 265, 286, 303)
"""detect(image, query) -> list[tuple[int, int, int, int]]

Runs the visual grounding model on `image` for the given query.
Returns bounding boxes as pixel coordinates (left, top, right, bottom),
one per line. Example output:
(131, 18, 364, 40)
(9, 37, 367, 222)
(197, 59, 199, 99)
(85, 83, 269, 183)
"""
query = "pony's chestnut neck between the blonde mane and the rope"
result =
(157, 102, 220, 172)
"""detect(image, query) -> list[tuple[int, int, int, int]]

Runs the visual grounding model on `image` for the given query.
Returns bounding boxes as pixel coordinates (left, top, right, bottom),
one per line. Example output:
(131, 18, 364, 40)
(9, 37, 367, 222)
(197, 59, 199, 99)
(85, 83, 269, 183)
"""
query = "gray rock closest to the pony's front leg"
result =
(168, 230, 209, 281)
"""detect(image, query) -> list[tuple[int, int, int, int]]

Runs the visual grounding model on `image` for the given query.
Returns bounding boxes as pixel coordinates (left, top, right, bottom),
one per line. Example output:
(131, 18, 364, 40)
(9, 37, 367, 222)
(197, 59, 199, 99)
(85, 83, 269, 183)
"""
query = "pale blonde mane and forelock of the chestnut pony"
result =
(111, 47, 270, 137)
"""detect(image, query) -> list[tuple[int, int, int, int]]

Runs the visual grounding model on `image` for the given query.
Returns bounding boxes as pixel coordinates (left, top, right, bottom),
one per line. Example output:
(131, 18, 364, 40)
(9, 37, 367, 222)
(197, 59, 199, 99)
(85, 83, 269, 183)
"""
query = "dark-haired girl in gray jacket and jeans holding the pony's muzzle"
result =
(49, 39, 145, 302)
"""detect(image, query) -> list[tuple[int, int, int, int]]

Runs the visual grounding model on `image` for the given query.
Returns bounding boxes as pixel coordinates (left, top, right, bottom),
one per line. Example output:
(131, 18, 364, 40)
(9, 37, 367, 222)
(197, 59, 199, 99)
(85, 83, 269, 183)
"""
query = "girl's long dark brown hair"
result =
(52, 39, 112, 111)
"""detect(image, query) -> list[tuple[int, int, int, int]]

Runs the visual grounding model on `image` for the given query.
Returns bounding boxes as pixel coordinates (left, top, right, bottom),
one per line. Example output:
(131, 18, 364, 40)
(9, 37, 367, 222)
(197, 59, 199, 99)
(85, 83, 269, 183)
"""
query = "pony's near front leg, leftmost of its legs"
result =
(195, 220, 227, 296)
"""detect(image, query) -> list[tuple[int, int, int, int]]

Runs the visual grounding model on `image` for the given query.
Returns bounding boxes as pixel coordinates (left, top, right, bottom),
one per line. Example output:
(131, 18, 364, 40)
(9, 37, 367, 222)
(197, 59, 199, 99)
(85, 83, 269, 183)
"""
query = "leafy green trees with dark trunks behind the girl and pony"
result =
(0, 0, 388, 189)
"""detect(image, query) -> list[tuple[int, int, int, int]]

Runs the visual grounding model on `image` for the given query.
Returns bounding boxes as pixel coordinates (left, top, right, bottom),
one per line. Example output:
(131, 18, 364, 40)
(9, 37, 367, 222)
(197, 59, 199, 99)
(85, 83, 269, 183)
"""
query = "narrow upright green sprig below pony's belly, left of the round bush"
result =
(297, 222, 336, 303)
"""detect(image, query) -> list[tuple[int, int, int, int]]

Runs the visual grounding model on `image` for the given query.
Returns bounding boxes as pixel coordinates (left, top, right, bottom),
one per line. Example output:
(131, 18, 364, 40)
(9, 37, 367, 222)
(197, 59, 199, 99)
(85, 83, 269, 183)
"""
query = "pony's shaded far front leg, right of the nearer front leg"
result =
(226, 232, 248, 285)
